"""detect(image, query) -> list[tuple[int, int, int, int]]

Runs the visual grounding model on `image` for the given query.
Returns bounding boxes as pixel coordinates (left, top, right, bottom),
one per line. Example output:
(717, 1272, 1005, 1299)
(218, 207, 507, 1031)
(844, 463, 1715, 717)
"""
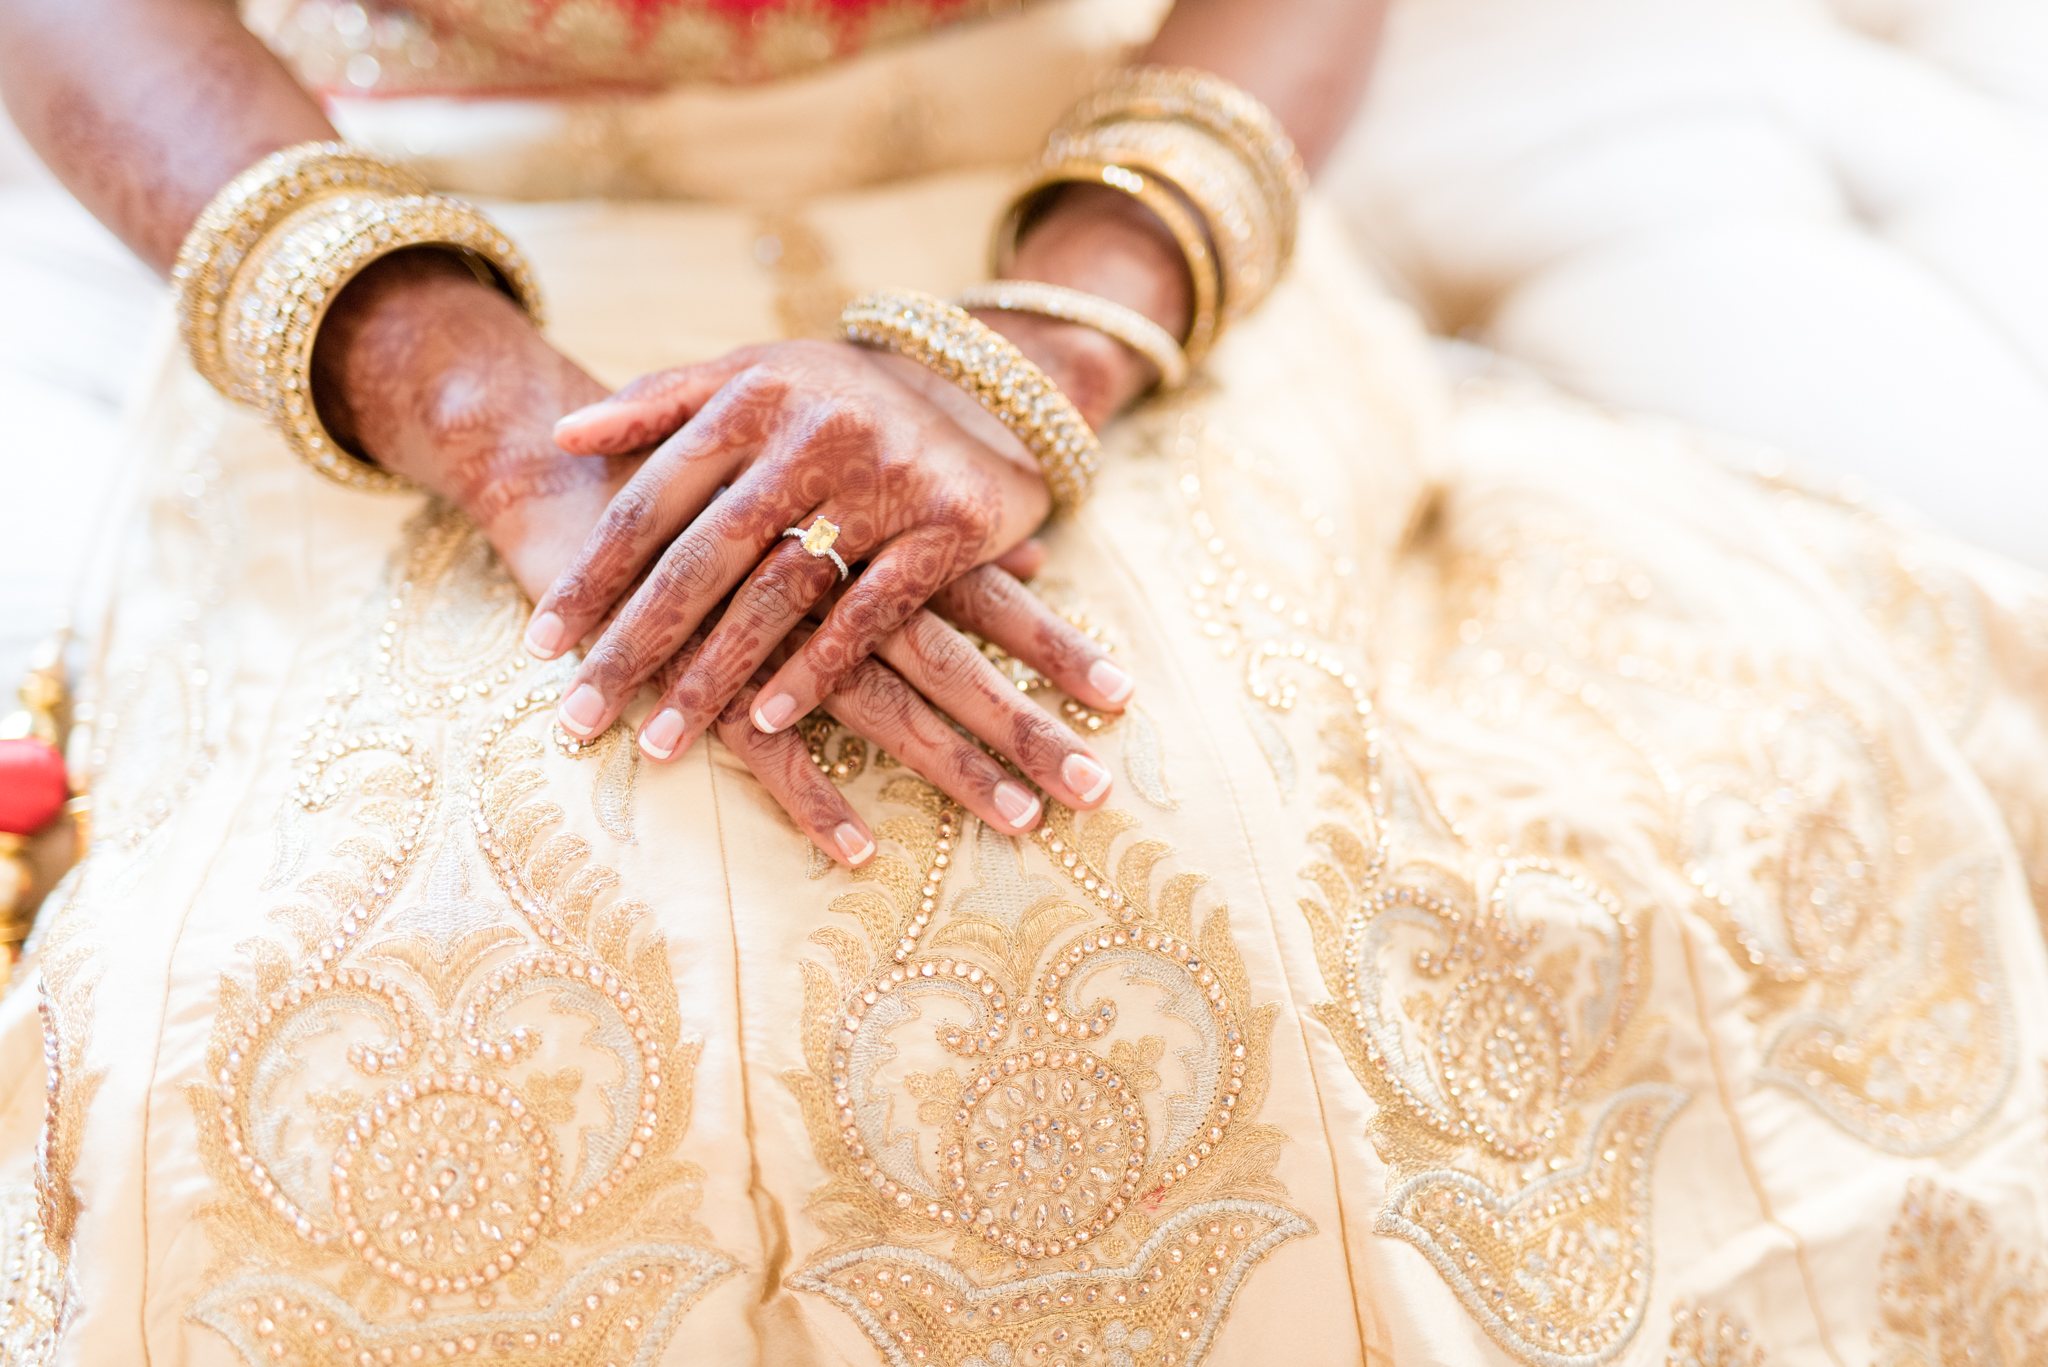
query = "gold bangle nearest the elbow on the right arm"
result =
(1055, 66, 1309, 266)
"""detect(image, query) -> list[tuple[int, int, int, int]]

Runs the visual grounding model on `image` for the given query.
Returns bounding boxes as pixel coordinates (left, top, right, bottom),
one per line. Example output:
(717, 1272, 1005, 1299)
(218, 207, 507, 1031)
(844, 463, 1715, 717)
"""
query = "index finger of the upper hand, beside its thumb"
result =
(526, 375, 766, 660)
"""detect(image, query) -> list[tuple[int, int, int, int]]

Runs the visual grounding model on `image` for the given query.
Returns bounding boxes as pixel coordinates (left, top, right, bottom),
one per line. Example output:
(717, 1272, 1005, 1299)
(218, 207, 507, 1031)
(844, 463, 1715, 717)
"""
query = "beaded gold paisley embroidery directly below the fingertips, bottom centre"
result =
(788, 777, 1311, 1367)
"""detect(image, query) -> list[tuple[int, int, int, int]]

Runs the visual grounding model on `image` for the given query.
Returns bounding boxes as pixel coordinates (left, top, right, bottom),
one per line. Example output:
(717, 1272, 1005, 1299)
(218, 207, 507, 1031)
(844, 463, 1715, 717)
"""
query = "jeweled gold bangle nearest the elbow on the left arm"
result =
(170, 141, 426, 404)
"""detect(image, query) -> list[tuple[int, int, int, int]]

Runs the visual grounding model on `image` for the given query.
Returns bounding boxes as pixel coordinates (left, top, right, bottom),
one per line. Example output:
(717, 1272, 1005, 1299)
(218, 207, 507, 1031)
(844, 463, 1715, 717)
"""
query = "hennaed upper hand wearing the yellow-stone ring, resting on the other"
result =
(528, 342, 1130, 778)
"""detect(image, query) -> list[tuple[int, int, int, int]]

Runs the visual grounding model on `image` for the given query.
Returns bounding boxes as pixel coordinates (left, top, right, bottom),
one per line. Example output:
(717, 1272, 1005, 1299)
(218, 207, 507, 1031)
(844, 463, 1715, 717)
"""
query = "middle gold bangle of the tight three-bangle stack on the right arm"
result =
(1051, 119, 1280, 334)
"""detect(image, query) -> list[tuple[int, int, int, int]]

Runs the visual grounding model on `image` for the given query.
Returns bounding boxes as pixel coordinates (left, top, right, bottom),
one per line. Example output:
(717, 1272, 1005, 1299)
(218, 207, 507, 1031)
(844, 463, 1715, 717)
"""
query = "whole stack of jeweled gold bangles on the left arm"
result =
(172, 141, 541, 490)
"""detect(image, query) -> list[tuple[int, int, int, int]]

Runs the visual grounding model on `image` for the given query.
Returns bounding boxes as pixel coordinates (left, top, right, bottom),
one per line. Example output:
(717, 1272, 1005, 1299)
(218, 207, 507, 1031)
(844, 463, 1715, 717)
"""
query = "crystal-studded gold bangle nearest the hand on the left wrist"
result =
(221, 195, 541, 492)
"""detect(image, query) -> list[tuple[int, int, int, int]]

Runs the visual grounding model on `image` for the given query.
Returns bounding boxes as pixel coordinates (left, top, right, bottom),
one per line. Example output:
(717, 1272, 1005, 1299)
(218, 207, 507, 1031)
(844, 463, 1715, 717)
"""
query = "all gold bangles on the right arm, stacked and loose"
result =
(842, 68, 1307, 514)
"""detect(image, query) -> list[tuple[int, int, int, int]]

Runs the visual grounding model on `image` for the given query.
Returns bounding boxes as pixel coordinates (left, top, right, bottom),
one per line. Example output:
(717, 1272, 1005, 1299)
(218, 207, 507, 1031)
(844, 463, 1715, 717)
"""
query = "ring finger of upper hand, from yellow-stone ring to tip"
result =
(639, 532, 840, 760)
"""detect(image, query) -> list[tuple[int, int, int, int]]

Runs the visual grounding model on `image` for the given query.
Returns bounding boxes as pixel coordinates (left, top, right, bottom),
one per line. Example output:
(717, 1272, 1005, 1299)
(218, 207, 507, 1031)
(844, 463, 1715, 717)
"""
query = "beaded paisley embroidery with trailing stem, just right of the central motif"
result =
(1176, 416, 1688, 1367)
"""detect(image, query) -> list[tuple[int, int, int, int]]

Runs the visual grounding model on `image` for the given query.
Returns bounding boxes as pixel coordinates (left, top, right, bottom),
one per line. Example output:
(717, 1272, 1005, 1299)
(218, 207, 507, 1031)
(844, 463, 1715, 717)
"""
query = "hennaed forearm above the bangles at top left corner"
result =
(0, 0, 334, 273)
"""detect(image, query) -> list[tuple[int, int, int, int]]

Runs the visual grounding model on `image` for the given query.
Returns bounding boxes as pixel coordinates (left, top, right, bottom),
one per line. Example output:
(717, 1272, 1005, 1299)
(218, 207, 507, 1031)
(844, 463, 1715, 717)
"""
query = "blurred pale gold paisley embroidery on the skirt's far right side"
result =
(1444, 489, 2015, 1154)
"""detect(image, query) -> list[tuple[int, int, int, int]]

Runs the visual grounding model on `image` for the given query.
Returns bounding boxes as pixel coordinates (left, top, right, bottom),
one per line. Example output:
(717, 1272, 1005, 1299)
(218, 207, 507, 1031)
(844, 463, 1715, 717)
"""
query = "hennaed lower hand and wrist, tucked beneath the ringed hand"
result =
(315, 252, 1128, 863)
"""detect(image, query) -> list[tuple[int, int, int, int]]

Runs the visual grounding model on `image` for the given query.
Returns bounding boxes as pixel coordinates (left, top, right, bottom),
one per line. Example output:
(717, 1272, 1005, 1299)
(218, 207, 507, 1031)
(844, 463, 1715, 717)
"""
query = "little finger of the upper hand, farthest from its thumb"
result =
(754, 533, 971, 732)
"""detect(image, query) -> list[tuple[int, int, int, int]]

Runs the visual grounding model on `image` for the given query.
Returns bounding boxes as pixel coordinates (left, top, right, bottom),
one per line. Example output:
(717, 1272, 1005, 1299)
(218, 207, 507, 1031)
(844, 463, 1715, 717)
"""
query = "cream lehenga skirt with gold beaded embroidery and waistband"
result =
(0, 4, 2048, 1367)
